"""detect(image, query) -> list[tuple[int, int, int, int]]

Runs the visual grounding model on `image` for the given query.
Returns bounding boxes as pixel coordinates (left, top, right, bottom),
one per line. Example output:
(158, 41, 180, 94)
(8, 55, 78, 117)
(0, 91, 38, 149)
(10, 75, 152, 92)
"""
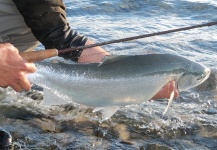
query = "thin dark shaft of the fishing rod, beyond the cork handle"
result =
(58, 22, 217, 55)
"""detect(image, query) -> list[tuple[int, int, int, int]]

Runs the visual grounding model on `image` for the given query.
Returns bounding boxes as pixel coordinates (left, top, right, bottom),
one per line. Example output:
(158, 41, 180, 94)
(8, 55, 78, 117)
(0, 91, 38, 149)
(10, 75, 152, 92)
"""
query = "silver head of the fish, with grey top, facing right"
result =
(177, 62, 210, 91)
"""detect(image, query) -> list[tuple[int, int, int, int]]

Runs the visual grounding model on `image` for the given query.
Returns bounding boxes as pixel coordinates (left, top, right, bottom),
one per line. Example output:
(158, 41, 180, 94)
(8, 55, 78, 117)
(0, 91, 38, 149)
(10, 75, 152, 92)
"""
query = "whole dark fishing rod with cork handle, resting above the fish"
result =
(20, 21, 217, 62)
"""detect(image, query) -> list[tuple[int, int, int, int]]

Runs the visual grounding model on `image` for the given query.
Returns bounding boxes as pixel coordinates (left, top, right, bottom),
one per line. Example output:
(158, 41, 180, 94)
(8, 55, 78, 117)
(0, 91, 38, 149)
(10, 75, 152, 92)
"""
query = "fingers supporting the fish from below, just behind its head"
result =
(151, 81, 179, 100)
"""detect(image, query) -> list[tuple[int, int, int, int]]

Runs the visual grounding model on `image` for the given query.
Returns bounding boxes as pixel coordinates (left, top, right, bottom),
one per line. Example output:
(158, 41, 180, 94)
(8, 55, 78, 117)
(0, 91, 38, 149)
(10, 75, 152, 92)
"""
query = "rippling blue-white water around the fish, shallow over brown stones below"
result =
(0, 0, 217, 150)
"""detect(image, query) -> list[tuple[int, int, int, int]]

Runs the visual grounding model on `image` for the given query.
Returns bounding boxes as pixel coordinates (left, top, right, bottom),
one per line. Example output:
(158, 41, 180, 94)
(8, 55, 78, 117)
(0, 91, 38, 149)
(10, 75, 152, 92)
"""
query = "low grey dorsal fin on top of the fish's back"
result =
(98, 55, 128, 67)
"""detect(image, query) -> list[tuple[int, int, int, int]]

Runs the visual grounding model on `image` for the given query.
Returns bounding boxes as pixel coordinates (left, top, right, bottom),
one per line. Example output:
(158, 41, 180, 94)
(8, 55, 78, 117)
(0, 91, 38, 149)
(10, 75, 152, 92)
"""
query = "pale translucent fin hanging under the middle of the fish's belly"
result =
(93, 106, 119, 121)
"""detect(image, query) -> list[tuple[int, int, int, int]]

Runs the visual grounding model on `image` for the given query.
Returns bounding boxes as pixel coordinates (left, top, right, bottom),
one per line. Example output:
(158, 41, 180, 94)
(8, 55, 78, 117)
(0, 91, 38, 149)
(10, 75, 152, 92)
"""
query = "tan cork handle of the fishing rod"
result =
(19, 49, 58, 62)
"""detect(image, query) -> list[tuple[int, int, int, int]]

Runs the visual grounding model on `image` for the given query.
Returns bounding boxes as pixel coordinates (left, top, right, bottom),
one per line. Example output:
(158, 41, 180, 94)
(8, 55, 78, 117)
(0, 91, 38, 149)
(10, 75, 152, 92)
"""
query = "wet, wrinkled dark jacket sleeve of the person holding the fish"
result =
(13, 0, 87, 61)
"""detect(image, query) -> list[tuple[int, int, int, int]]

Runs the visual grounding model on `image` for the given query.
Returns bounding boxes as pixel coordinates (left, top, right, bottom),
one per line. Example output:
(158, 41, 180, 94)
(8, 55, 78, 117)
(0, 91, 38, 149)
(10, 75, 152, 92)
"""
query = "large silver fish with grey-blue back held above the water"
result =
(28, 54, 210, 119)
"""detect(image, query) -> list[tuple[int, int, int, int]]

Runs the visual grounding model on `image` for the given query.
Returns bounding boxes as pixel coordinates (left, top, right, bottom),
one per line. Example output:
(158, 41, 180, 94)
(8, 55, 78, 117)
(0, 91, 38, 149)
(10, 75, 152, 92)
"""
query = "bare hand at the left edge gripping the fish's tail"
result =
(0, 43, 36, 92)
